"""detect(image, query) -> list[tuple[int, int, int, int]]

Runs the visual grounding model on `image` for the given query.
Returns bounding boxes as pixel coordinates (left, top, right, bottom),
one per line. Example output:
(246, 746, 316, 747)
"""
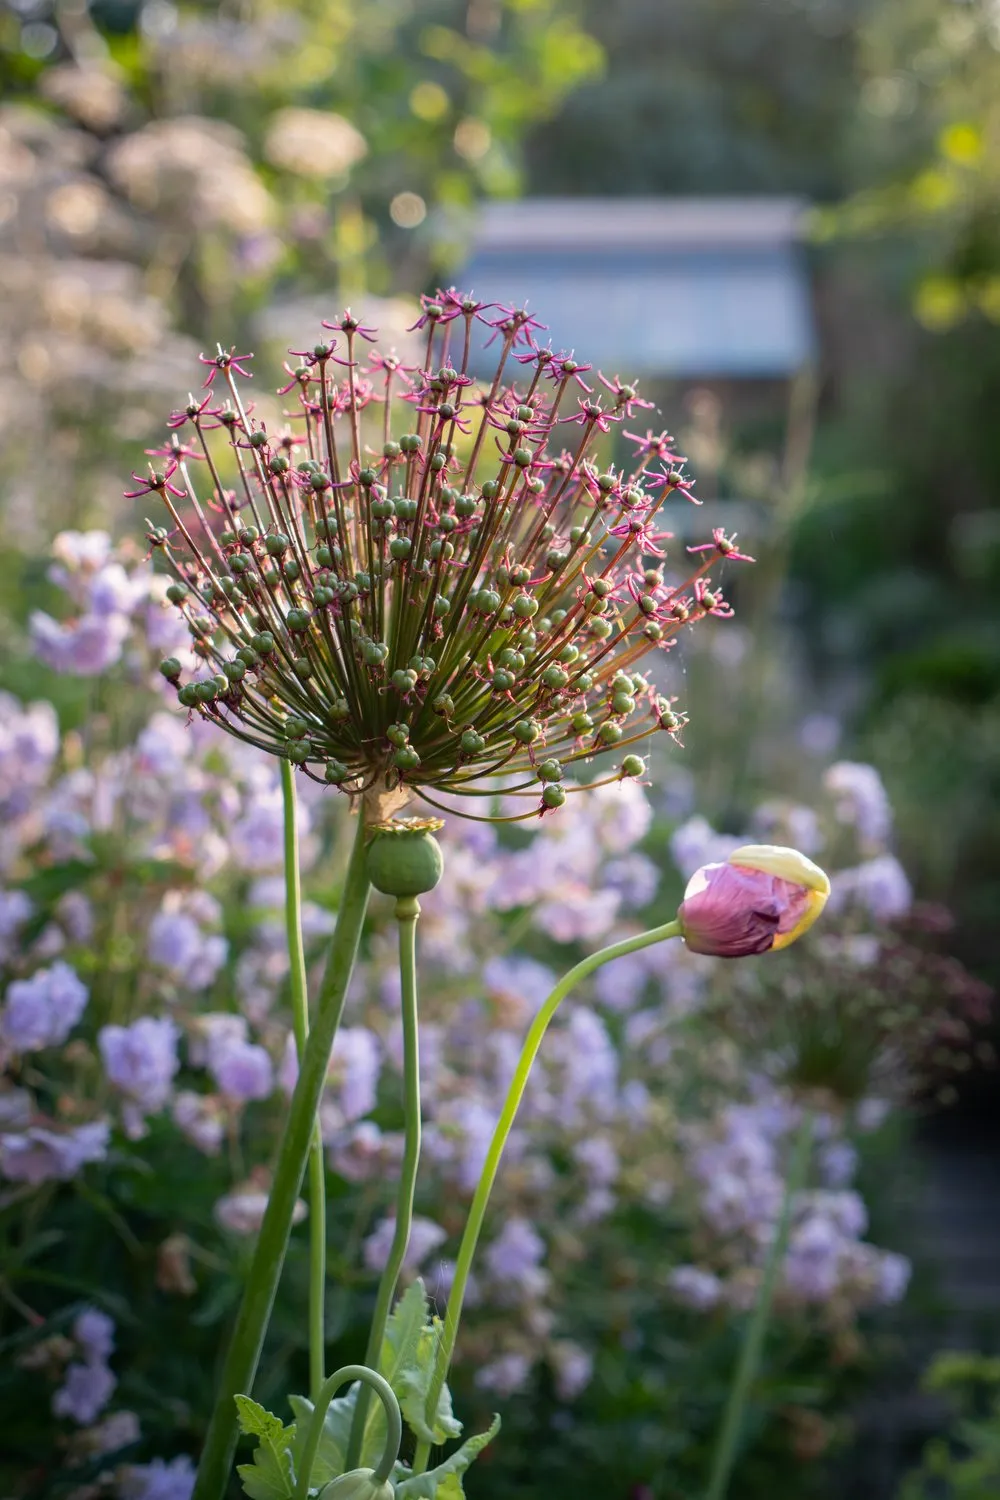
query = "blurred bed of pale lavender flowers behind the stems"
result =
(0, 531, 988, 1500)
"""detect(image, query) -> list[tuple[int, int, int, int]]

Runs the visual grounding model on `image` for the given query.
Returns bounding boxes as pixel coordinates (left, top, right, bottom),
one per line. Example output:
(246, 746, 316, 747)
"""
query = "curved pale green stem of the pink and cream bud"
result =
(412, 921, 681, 1475)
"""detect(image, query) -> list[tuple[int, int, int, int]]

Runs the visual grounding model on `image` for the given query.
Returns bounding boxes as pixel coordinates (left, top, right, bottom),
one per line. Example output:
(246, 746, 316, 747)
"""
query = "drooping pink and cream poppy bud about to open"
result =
(678, 845, 831, 959)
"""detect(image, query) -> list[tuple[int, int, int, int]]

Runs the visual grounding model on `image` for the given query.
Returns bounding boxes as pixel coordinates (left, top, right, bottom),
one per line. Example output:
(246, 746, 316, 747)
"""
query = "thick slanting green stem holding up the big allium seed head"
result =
(192, 815, 370, 1500)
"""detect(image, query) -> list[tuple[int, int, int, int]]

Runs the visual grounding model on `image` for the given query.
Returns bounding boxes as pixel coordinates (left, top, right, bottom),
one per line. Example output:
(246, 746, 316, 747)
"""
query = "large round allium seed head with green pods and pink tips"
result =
(137, 291, 744, 816)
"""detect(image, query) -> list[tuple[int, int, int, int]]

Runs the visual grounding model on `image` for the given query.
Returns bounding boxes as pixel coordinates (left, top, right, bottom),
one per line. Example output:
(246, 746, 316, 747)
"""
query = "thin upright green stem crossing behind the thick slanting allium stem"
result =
(280, 761, 327, 1401)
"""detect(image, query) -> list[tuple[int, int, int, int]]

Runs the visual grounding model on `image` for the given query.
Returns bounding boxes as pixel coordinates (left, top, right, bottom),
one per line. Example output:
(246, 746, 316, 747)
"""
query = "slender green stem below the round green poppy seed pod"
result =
(346, 897, 421, 1469)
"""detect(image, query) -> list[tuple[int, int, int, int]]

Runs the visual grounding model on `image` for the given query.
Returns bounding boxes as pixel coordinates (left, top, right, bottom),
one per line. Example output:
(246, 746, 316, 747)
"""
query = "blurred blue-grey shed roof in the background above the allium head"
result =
(460, 200, 814, 378)
